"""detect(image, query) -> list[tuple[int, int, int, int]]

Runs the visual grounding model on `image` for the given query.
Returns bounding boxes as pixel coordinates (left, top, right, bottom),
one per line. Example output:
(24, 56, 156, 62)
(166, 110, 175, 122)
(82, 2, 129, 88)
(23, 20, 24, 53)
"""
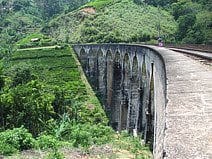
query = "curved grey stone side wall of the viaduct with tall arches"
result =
(73, 44, 167, 158)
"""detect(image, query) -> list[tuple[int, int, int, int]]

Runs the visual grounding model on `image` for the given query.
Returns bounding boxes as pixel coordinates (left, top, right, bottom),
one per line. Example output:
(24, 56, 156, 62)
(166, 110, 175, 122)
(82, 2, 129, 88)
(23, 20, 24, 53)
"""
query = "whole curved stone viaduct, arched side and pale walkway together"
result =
(73, 44, 212, 159)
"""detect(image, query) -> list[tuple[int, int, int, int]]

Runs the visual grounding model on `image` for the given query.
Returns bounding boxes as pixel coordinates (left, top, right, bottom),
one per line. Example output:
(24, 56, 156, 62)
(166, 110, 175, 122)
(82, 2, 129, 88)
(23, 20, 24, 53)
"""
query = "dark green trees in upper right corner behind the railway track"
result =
(171, 0, 212, 44)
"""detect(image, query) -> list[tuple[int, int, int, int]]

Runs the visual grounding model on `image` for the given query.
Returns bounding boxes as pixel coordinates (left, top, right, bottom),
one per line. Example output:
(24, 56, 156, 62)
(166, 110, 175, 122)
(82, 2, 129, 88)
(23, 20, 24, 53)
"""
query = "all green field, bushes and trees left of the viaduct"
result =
(0, 47, 151, 158)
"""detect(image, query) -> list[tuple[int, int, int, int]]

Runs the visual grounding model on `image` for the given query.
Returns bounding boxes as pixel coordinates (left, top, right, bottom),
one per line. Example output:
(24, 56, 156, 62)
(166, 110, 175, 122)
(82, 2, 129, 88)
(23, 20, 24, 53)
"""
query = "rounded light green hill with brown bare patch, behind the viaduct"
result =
(43, 0, 177, 43)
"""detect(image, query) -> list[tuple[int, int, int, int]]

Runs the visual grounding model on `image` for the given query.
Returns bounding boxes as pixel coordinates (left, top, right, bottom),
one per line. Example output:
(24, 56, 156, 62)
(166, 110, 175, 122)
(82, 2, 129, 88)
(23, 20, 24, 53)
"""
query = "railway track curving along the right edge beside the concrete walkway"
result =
(169, 48, 212, 67)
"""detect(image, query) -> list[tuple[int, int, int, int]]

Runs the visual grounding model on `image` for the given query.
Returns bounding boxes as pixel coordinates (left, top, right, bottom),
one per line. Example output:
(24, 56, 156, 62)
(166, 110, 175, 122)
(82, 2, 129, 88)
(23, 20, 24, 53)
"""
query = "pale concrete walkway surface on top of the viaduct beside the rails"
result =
(152, 47, 212, 159)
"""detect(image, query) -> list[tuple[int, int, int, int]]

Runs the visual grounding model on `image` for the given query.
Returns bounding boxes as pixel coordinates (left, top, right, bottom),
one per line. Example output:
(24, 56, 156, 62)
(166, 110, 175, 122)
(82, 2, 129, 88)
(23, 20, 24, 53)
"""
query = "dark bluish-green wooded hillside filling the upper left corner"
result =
(0, 0, 87, 53)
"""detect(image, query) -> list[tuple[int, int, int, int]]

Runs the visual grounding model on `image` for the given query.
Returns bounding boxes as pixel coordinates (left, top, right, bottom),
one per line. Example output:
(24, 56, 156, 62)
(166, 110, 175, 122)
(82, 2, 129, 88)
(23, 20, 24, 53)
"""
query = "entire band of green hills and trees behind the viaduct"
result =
(0, 0, 212, 51)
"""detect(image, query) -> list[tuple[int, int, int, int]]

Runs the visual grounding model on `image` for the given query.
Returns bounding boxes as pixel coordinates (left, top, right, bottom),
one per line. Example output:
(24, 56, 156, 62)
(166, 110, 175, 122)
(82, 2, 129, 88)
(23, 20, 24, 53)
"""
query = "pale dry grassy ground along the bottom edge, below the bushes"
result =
(2, 133, 153, 159)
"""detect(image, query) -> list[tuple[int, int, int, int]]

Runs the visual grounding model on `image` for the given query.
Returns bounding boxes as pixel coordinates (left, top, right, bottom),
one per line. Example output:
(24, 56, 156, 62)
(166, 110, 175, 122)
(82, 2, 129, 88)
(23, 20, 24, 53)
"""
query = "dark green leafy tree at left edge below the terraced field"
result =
(0, 80, 54, 135)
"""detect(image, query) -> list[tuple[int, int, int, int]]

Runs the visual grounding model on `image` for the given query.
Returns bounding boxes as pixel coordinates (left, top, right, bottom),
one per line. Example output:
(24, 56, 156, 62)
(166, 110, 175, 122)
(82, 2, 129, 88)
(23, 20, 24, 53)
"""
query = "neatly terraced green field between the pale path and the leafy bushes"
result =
(11, 48, 82, 87)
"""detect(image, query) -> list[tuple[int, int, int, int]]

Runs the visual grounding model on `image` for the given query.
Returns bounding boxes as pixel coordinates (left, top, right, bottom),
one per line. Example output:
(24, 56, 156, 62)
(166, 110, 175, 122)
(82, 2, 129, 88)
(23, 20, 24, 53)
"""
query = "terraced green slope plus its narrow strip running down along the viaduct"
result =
(8, 46, 107, 117)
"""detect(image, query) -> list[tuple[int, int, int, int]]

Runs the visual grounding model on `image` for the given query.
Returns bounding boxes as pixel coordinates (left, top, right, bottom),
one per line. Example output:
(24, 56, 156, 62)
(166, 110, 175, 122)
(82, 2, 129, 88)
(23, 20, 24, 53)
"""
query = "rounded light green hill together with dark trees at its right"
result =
(42, 0, 212, 44)
